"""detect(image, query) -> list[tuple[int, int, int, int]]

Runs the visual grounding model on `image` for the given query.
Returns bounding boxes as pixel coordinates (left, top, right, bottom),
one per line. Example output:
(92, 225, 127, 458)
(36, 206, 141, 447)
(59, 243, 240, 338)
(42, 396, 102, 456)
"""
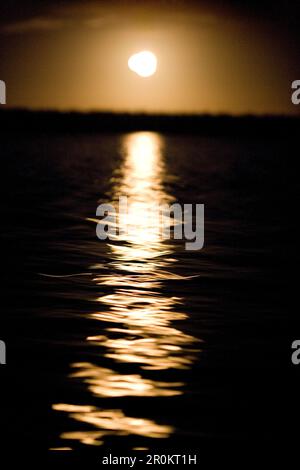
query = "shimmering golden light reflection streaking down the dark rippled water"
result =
(53, 132, 196, 445)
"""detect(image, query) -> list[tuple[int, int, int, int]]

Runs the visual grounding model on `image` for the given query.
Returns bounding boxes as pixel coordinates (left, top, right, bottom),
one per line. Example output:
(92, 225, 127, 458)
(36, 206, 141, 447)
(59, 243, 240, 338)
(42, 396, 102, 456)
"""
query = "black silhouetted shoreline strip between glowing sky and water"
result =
(0, 109, 300, 137)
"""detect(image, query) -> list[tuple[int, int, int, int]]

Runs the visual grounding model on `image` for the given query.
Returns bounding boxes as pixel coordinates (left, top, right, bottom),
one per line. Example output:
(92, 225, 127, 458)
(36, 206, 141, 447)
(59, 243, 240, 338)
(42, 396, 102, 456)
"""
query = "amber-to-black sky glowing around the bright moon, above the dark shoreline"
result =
(0, 0, 300, 113)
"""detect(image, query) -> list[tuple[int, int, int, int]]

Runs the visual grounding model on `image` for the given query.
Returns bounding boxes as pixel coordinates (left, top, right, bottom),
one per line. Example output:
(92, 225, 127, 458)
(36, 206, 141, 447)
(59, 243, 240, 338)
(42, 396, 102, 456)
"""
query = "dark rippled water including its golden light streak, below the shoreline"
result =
(1, 131, 296, 456)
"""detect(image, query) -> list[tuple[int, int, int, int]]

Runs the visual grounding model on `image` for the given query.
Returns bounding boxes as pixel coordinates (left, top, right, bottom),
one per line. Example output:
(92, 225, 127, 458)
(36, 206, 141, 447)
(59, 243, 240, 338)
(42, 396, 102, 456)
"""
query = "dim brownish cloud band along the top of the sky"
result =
(0, 0, 217, 35)
